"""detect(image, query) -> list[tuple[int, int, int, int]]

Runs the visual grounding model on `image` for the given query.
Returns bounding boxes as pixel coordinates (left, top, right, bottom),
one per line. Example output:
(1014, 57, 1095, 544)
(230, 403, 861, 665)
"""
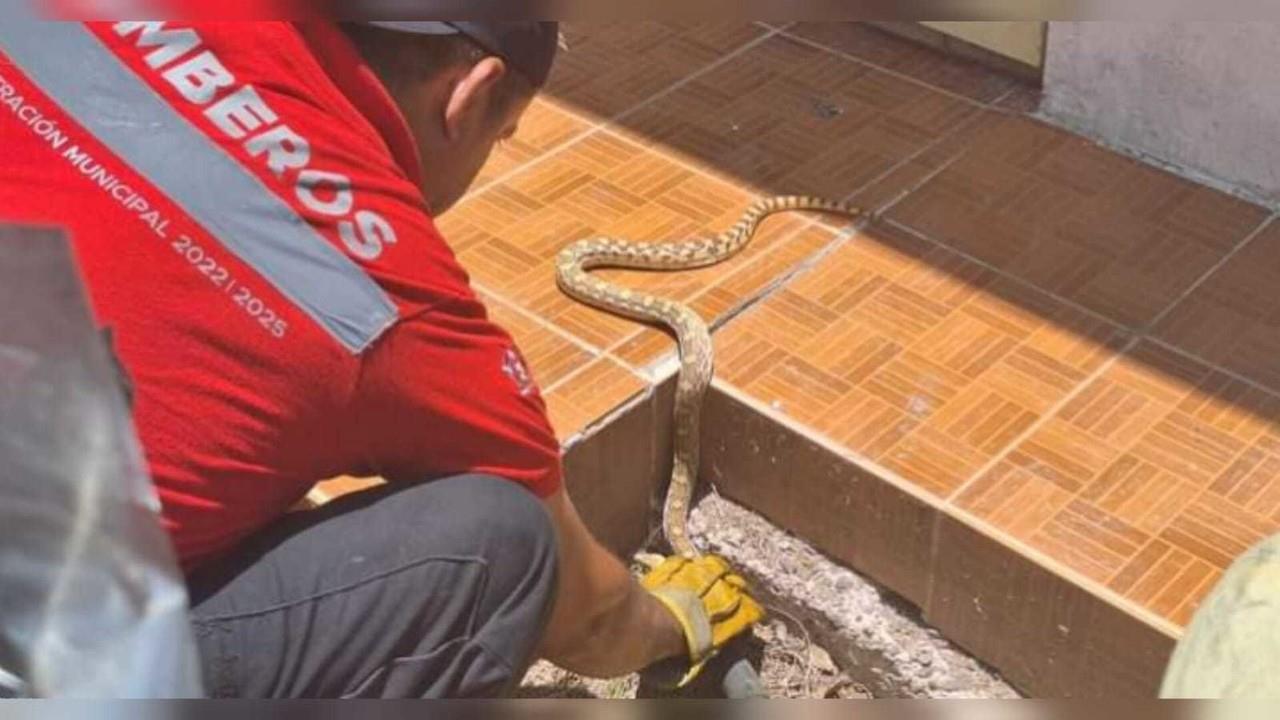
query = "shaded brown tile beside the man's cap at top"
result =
(545, 22, 767, 118)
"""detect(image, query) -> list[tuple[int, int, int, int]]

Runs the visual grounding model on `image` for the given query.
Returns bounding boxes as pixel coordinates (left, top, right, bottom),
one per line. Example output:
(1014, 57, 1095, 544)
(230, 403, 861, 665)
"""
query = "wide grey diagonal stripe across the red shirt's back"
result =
(0, 22, 397, 354)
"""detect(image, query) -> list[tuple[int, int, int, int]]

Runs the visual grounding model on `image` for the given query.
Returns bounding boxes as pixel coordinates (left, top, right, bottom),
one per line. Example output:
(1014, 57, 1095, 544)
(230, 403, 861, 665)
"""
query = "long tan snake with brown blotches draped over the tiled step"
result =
(556, 196, 863, 557)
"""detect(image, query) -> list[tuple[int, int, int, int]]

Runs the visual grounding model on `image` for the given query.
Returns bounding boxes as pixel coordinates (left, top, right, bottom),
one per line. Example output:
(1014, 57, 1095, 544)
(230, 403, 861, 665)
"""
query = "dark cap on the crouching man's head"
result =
(369, 20, 559, 87)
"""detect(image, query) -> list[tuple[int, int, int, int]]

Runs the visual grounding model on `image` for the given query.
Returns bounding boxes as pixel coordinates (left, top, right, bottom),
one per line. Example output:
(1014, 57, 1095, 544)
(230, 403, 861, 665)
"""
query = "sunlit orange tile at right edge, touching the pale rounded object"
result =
(955, 341, 1280, 623)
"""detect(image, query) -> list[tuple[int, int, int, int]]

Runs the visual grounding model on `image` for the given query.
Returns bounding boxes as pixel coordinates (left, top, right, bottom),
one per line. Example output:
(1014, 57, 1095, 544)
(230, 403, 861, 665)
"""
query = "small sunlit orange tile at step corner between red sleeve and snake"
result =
(545, 359, 648, 442)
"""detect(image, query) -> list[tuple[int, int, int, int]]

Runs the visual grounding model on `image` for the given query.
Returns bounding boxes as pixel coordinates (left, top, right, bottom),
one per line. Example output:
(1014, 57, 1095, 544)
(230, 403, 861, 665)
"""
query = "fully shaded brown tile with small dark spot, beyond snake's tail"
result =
(620, 32, 977, 199)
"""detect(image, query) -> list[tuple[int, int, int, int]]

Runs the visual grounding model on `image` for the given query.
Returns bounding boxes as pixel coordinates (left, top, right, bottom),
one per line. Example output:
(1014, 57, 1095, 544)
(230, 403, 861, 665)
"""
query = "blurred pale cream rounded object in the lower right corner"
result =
(1160, 536, 1280, 700)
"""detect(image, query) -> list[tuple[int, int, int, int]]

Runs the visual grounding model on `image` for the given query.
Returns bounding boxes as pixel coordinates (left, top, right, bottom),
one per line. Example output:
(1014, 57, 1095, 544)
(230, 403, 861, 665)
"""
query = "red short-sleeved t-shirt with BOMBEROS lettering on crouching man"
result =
(0, 19, 561, 569)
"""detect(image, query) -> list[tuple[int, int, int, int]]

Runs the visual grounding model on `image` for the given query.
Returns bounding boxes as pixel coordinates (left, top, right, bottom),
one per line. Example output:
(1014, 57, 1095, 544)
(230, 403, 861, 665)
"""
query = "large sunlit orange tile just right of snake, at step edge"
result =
(717, 220, 1120, 498)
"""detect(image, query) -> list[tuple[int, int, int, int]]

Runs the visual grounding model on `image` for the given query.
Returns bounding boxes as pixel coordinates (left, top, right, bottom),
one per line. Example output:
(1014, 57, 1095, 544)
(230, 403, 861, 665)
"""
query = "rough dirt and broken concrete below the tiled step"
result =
(520, 493, 1019, 698)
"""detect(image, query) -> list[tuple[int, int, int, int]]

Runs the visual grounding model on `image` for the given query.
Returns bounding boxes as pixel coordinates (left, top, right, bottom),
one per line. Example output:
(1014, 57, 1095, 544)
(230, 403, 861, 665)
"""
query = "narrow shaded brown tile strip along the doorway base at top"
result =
(787, 22, 1018, 102)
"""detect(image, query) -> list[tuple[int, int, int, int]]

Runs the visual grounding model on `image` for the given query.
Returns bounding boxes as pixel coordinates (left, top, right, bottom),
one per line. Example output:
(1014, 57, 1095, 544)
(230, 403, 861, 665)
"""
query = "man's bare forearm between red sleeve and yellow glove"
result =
(540, 489, 689, 678)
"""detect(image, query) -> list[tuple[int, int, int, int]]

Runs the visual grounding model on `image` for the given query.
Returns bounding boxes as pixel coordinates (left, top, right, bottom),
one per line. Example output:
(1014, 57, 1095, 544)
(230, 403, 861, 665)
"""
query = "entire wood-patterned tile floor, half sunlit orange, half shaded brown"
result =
(322, 23, 1280, 632)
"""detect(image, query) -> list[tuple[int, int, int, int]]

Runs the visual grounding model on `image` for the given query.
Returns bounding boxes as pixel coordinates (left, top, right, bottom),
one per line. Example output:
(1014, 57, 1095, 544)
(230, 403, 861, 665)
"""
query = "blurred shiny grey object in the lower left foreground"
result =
(0, 224, 201, 698)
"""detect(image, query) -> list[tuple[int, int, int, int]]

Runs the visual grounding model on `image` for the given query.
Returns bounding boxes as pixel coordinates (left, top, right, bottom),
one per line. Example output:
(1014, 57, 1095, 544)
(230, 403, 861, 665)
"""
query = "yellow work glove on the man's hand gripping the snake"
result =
(641, 555, 764, 687)
